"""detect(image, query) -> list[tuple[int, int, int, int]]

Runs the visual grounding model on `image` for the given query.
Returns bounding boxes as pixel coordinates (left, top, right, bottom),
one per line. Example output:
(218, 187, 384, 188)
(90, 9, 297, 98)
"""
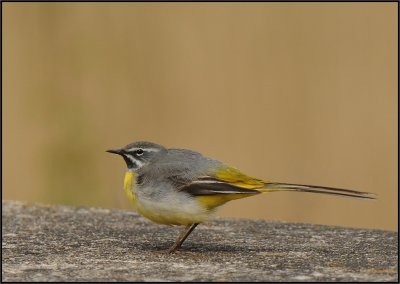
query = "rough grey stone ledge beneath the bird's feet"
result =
(2, 201, 398, 282)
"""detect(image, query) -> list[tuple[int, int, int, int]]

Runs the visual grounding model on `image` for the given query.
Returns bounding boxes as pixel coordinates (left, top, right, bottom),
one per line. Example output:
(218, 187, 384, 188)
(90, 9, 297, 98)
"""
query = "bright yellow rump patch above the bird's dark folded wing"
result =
(215, 168, 265, 189)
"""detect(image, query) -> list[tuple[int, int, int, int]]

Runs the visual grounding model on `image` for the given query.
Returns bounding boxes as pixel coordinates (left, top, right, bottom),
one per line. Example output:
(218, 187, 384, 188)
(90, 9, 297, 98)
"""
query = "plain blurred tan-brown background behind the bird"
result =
(2, 3, 398, 230)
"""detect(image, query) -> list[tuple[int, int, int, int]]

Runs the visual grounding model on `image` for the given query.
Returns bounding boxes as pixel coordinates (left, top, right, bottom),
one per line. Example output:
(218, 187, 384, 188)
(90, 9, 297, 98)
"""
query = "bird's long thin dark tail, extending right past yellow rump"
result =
(260, 182, 376, 199)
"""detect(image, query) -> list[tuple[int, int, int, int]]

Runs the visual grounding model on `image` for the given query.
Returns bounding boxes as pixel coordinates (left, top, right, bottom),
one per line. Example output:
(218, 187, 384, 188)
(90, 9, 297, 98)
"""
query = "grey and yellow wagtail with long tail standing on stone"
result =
(106, 141, 375, 253)
